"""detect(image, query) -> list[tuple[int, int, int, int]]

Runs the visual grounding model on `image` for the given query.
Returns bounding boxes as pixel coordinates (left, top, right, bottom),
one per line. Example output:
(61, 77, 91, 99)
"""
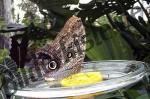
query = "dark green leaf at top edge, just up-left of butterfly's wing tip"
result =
(31, 0, 79, 17)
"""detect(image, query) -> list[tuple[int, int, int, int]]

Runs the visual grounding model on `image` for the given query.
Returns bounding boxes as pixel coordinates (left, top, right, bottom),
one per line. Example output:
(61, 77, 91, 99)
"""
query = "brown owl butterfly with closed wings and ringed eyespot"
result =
(35, 16, 86, 80)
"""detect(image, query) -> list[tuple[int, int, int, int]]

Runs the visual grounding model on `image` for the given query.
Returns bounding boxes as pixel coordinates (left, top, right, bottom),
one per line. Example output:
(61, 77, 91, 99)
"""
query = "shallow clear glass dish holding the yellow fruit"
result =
(10, 60, 146, 99)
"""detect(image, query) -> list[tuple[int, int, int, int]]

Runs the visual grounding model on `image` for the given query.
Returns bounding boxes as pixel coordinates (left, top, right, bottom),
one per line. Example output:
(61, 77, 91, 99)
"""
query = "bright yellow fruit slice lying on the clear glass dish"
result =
(60, 72, 103, 87)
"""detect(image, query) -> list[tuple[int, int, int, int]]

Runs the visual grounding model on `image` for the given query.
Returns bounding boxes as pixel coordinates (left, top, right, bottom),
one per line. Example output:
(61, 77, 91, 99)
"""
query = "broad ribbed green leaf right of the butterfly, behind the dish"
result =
(87, 24, 133, 60)
